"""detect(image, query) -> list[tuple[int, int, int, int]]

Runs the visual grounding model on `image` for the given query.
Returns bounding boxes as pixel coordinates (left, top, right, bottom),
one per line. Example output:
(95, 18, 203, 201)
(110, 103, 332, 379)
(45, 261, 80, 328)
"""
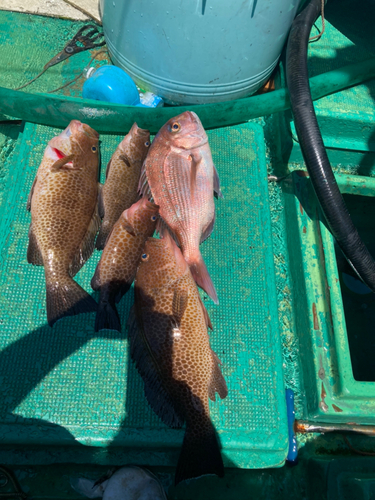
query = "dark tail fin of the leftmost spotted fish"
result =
(46, 276, 98, 326)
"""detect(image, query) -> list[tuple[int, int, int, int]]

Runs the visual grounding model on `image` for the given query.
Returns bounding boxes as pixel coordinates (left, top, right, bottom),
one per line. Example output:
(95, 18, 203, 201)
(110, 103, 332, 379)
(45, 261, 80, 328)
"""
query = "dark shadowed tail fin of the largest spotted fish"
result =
(175, 417, 224, 485)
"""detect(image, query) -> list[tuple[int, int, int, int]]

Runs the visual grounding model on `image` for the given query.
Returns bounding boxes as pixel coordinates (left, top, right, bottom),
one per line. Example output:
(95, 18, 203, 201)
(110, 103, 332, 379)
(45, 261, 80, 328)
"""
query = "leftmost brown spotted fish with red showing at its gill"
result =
(27, 120, 100, 326)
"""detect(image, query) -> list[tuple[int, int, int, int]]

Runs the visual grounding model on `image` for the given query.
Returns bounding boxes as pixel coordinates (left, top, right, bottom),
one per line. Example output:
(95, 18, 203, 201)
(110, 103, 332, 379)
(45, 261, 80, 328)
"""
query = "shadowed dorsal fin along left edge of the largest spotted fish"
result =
(128, 302, 184, 428)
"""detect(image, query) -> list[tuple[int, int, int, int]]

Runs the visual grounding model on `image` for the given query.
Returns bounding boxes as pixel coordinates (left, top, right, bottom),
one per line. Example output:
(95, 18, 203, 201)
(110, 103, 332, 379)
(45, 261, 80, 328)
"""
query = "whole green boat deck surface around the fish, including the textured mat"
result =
(0, 0, 375, 500)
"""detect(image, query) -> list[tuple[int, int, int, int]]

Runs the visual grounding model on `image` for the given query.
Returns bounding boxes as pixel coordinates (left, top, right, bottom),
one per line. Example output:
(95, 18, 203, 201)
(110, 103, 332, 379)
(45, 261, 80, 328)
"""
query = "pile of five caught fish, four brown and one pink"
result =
(27, 111, 228, 484)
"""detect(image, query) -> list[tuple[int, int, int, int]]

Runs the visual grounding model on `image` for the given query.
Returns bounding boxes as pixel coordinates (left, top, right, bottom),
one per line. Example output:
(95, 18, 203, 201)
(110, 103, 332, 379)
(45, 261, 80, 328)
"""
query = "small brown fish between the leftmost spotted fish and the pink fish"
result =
(96, 123, 150, 250)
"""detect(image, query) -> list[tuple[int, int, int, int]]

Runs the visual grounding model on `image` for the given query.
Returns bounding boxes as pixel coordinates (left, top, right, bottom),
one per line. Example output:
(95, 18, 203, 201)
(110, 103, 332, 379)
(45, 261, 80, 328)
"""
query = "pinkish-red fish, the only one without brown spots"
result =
(139, 111, 222, 303)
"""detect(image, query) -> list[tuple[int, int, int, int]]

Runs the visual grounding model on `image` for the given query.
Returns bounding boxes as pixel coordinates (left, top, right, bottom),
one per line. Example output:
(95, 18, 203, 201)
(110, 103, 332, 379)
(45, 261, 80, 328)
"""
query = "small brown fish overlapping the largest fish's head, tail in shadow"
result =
(91, 198, 159, 332)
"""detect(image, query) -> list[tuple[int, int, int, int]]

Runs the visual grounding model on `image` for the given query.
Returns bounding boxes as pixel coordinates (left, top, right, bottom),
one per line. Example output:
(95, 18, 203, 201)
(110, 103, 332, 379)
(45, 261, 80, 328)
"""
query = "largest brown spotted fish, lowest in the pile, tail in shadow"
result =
(128, 233, 228, 484)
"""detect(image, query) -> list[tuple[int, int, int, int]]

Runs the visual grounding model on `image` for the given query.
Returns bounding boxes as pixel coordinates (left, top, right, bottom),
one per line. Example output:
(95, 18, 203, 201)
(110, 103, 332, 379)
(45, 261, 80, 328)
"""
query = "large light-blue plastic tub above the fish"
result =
(100, 0, 301, 104)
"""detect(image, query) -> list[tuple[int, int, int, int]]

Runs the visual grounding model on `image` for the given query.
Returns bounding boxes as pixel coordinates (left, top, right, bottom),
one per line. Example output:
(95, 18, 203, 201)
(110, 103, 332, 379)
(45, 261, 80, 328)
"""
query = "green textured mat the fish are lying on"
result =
(0, 123, 288, 468)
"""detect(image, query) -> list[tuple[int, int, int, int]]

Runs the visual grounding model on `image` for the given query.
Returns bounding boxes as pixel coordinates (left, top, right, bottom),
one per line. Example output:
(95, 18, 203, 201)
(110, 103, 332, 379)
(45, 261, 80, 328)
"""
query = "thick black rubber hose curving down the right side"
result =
(286, 0, 375, 292)
